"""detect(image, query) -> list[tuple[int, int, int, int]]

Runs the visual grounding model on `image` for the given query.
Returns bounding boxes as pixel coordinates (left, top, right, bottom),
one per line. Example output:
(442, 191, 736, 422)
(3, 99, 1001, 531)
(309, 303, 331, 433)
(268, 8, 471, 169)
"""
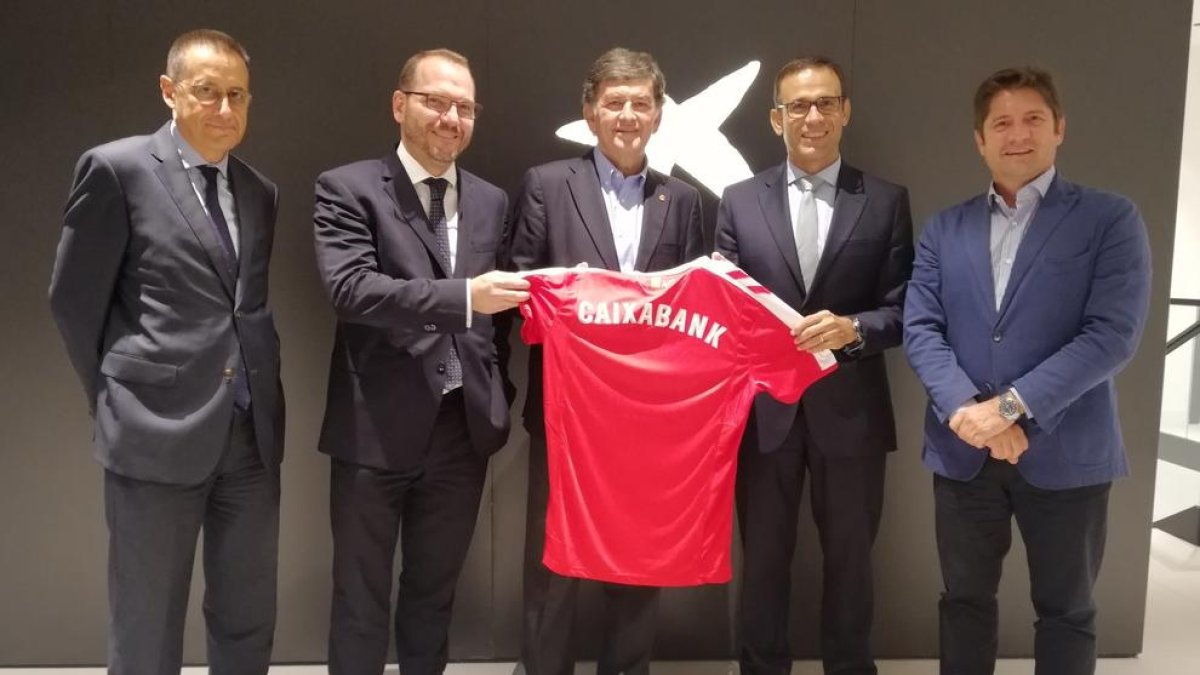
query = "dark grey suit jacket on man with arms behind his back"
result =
(50, 123, 283, 484)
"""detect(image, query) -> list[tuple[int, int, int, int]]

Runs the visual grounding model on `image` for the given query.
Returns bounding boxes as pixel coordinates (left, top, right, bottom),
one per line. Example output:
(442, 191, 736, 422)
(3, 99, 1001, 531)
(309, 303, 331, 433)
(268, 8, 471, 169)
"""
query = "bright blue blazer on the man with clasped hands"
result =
(905, 177, 1151, 489)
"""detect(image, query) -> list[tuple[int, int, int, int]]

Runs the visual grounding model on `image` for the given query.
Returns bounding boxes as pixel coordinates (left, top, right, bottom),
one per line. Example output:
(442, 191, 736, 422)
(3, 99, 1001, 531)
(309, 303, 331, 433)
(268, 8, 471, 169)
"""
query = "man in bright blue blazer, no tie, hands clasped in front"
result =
(905, 67, 1151, 675)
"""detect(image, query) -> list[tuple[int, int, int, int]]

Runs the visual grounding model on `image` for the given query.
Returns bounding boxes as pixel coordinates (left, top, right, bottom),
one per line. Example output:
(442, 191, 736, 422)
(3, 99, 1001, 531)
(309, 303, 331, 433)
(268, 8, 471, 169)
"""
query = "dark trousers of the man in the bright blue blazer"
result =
(934, 459, 1110, 675)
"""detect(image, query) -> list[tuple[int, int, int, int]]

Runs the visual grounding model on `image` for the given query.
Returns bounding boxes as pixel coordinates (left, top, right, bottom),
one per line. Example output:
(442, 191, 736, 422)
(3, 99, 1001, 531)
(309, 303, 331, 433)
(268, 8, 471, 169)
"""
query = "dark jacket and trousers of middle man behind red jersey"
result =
(509, 151, 703, 675)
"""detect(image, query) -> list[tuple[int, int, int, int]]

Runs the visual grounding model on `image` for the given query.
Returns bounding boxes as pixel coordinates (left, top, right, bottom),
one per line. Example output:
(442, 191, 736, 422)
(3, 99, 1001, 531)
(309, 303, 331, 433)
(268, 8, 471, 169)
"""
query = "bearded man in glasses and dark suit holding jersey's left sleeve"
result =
(313, 49, 528, 675)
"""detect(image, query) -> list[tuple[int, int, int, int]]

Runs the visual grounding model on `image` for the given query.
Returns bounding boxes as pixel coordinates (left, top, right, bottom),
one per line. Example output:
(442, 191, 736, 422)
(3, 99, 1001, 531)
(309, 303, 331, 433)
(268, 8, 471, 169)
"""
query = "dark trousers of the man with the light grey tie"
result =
(737, 414, 887, 675)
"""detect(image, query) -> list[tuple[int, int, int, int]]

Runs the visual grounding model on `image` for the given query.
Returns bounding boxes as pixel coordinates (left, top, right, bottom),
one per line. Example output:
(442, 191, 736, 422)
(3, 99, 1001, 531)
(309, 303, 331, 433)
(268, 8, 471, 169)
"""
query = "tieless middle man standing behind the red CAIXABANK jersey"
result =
(509, 48, 704, 675)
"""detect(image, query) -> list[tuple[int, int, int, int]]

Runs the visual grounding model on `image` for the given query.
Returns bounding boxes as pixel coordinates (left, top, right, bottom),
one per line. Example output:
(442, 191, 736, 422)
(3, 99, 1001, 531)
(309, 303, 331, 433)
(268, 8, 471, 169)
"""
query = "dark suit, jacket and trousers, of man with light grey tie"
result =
(716, 163, 913, 674)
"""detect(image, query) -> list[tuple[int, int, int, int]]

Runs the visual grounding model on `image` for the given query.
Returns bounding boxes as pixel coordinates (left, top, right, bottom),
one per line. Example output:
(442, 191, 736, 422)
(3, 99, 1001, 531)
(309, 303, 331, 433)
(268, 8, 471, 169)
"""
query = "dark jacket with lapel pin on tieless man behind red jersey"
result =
(508, 150, 706, 434)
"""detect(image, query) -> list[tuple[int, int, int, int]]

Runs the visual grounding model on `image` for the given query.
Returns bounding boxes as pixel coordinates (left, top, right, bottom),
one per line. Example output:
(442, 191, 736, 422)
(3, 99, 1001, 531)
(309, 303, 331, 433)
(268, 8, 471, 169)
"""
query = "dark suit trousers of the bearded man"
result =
(329, 392, 487, 675)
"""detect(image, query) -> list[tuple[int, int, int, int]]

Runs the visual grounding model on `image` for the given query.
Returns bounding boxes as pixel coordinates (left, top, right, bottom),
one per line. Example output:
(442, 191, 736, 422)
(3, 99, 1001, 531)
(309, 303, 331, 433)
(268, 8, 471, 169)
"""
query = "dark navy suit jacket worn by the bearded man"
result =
(313, 151, 509, 471)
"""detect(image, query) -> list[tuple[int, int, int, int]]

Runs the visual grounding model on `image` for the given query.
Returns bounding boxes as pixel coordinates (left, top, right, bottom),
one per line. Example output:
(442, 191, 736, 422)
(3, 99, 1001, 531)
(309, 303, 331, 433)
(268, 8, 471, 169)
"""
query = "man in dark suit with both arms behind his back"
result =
(50, 30, 283, 674)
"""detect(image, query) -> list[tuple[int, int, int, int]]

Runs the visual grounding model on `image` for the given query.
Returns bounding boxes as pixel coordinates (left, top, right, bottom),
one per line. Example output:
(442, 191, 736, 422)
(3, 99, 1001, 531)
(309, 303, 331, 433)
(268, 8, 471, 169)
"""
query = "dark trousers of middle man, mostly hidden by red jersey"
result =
(521, 434, 659, 675)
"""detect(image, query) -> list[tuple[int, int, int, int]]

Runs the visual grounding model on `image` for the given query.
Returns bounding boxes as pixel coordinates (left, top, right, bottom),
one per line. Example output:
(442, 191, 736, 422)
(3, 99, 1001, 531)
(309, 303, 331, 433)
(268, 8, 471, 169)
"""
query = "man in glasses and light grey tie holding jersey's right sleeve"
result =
(716, 56, 912, 675)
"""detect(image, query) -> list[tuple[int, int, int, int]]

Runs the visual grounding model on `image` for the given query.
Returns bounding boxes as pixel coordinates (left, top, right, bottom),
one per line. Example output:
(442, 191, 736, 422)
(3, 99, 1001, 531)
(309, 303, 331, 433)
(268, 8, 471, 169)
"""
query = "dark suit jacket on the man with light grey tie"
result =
(716, 162, 913, 458)
